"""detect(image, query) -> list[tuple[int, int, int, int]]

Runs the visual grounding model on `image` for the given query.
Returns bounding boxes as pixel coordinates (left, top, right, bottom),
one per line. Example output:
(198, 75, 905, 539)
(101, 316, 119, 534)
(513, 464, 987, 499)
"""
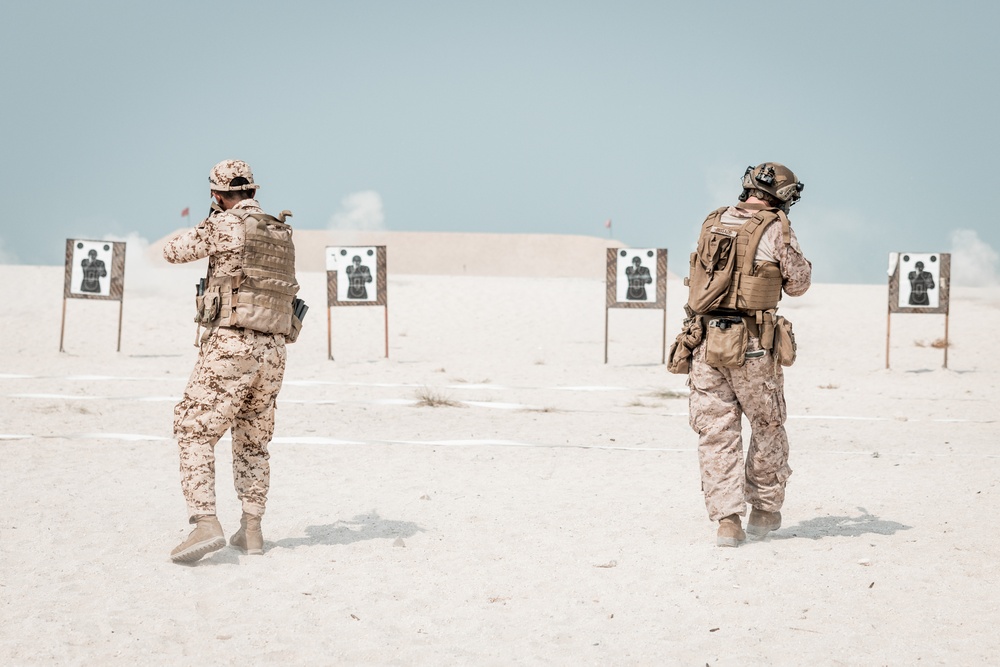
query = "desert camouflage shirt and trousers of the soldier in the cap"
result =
(163, 199, 285, 517)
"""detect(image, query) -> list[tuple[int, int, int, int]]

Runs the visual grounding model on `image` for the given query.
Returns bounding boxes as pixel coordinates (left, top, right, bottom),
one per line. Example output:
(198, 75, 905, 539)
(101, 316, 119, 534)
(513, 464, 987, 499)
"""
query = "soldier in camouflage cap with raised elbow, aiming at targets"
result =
(163, 160, 298, 562)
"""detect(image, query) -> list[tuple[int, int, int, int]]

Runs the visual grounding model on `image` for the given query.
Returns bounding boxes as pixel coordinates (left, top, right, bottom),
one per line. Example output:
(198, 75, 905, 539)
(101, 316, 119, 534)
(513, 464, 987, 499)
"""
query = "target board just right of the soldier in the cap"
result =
(326, 246, 387, 307)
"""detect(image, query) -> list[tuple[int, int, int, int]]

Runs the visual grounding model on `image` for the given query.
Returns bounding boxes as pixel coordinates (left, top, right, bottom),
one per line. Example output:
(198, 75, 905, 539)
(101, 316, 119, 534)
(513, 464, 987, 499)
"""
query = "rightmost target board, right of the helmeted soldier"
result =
(889, 252, 951, 314)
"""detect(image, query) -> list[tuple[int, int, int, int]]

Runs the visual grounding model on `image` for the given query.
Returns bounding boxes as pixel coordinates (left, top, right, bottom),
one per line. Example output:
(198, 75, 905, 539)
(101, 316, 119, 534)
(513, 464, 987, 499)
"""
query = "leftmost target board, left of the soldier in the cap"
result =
(63, 239, 125, 301)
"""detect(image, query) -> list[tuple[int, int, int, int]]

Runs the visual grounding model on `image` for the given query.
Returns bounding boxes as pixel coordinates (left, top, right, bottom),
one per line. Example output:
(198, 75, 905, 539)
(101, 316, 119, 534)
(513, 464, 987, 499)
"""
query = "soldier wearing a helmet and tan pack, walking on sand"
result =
(671, 162, 812, 547)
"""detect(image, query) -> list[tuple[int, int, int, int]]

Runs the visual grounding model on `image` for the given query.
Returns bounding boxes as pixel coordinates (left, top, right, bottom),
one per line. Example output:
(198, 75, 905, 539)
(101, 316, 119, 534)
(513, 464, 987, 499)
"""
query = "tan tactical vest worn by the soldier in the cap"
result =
(206, 209, 299, 335)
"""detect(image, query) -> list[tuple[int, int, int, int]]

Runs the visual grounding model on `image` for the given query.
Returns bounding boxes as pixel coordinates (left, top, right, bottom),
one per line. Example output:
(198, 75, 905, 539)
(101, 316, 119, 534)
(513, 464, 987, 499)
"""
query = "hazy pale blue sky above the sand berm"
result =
(0, 0, 1000, 282)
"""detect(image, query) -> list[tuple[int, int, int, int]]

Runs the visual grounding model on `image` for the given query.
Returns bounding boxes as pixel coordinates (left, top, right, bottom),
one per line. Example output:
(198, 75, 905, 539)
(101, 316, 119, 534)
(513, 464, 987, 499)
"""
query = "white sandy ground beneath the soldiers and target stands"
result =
(0, 239, 1000, 665)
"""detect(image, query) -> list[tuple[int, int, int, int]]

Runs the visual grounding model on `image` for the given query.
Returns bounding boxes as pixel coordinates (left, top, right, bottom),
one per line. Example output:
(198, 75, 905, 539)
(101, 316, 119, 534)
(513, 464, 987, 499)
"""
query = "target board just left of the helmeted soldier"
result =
(607, 248, 667, 310)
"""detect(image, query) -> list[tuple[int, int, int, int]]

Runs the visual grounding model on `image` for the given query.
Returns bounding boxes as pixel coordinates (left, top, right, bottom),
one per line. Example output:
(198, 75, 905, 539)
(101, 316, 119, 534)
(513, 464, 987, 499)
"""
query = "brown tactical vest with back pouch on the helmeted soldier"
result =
(684, 206, 791, 315)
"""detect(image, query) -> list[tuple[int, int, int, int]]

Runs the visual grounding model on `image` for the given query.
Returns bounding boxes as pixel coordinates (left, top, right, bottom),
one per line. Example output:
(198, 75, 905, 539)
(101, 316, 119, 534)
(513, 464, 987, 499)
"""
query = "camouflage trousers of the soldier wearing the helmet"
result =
(688, 337, 792, 521)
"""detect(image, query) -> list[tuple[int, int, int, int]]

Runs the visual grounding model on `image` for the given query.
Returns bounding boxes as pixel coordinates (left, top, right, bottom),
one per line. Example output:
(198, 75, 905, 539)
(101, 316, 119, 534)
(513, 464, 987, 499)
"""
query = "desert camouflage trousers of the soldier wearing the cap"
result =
(174, 327, 285, 517)
